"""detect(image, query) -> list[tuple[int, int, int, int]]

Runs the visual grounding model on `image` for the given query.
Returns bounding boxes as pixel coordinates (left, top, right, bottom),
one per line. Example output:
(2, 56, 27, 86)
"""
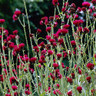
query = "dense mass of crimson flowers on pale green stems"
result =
(0, 0, 96, 96)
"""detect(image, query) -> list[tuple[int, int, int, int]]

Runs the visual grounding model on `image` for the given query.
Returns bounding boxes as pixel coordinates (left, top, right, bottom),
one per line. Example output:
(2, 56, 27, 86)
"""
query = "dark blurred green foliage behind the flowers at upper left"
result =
(0, 0, 50, 42)
